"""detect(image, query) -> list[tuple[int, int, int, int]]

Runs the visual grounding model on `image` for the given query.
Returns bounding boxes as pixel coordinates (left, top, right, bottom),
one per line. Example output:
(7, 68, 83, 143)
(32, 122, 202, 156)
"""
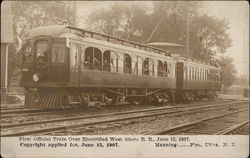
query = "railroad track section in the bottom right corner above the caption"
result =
(145, 108, 249, 135)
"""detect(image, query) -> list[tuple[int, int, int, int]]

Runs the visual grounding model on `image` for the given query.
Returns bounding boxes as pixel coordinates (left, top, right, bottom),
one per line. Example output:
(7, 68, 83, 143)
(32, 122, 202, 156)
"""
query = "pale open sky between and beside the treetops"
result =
(77, 1, 249, 76)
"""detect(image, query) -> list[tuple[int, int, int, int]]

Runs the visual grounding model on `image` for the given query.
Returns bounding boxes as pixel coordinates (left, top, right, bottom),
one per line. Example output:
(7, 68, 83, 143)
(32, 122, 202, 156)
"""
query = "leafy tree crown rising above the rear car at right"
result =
(193, 14, 232, 60)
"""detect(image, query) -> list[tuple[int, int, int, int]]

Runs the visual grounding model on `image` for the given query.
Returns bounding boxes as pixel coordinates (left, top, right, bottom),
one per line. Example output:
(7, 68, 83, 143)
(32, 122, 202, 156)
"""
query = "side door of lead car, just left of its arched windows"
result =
(70, 43, 81, 86)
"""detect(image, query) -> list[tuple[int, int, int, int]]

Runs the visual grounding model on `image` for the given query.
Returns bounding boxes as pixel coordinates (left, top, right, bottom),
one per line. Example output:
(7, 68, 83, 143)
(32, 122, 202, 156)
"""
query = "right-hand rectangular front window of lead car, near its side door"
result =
(51, 44, 65, 63)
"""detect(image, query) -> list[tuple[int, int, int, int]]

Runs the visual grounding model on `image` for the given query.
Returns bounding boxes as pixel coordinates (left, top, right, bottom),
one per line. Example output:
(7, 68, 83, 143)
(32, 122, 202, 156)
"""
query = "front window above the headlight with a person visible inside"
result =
(36, 41, 49, 63)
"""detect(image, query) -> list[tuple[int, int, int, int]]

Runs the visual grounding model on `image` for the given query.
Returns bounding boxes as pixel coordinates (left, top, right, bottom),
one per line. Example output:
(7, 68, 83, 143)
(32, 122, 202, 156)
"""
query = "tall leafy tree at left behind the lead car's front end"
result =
(8, 1, 74, 86)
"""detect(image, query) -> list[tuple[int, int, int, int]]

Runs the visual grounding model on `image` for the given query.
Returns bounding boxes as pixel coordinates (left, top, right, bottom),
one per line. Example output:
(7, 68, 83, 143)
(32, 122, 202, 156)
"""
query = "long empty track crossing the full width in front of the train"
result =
(1, 101, 246, 136)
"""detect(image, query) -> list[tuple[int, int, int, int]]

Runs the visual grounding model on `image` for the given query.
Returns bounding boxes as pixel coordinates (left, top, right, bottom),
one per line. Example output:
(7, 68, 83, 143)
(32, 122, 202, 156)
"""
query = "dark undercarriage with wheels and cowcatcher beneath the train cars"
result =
(25, 87, 216, 109)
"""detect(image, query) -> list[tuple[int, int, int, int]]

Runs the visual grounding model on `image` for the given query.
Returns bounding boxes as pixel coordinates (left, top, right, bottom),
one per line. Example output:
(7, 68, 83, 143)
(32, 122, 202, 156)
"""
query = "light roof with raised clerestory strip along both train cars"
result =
(29, 25, 218, 68)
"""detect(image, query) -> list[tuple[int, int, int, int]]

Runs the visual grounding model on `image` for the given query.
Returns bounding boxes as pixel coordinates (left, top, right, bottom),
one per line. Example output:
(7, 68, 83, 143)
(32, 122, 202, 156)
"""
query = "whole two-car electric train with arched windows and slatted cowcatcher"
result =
(20, 26, 221, 108)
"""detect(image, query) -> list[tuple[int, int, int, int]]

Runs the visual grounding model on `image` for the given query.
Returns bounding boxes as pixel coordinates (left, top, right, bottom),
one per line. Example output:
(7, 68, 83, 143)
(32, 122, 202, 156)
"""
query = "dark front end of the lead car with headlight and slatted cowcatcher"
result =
(20, 25, 69, 108)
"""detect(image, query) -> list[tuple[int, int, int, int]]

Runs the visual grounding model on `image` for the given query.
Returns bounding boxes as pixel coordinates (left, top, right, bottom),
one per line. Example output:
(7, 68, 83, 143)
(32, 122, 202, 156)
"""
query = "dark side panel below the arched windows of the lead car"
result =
(76, 70, 176, 89)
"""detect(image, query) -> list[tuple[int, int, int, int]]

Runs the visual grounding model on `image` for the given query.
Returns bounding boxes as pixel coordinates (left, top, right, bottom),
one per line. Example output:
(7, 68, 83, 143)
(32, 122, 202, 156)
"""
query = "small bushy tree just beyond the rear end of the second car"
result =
(217, 56, 237, 88)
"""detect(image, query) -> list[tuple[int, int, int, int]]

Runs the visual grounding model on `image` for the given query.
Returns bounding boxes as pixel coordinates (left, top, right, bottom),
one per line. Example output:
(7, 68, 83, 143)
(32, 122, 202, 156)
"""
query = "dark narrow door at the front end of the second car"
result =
(176, 62, 184, 89)
